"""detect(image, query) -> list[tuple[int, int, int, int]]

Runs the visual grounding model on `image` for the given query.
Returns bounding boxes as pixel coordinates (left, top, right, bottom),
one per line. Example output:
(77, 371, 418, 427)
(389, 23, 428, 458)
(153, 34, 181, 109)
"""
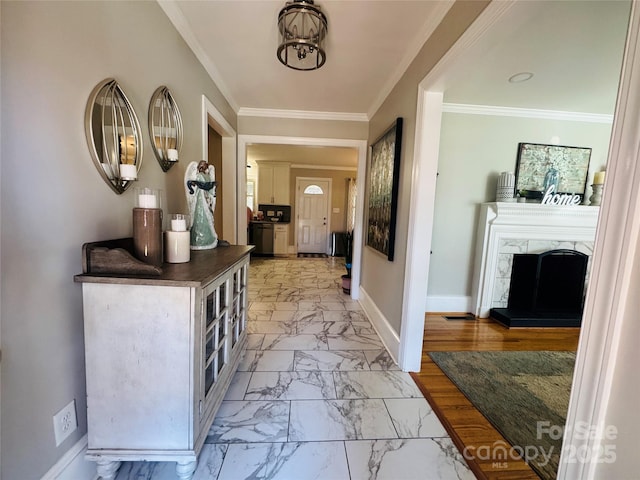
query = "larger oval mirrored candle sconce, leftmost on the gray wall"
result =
(84, 78, 142, 194)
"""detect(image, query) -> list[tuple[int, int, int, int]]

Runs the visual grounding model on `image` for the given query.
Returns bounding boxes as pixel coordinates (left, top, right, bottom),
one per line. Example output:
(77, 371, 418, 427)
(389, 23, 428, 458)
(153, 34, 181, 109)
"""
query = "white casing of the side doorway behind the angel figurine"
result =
(202, 95, 238, 244)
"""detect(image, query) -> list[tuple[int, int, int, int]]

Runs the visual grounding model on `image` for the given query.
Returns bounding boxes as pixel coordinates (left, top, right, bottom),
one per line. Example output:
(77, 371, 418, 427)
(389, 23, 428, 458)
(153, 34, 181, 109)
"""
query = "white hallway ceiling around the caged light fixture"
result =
(159, 0, 451, 114)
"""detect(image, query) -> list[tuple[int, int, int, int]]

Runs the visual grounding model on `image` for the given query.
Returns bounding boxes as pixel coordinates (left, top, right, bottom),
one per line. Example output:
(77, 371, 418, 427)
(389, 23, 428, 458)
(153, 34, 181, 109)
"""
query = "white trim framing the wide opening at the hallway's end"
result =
(238, 135, 368, 300)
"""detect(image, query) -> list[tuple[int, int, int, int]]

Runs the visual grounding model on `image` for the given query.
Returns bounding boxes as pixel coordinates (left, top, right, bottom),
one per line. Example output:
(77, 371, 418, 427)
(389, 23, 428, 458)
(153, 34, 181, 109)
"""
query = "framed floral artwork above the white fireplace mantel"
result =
(516, 143, 591, 200)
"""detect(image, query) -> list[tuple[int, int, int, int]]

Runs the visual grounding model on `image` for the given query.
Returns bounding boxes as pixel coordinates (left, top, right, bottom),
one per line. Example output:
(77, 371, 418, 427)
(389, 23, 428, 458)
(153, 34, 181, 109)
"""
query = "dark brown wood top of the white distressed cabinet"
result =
(73, 245, 255, 287)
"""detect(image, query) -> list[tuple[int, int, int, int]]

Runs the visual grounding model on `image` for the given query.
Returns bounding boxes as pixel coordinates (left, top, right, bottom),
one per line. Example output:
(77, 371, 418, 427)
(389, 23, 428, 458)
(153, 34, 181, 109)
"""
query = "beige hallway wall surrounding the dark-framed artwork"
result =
(361, 1, 488, 333)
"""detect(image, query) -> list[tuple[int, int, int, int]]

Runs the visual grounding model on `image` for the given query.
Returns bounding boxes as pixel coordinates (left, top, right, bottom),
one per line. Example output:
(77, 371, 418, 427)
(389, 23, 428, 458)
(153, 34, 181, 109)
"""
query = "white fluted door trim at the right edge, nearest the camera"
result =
(557, 1, 640, 480)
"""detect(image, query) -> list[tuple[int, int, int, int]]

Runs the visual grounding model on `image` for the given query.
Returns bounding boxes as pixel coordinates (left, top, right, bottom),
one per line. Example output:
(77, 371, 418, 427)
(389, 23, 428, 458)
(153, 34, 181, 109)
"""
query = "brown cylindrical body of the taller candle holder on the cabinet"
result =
(133, 208, 163, 267)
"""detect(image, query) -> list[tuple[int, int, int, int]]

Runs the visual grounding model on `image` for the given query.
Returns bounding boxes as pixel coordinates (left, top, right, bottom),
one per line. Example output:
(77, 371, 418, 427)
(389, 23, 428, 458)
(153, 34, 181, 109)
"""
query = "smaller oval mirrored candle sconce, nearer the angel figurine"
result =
(149, 86, 182, 172)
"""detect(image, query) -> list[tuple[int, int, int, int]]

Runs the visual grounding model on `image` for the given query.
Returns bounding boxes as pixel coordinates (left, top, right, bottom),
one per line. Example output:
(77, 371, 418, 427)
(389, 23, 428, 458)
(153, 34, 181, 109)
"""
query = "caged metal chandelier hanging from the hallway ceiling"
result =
(278, 0, 327, 70)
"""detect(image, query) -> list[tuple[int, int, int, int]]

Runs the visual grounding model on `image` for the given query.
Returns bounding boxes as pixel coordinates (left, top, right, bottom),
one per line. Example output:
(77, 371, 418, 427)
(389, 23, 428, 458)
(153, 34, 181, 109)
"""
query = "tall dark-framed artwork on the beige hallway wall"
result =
(366, 118, 402, 262)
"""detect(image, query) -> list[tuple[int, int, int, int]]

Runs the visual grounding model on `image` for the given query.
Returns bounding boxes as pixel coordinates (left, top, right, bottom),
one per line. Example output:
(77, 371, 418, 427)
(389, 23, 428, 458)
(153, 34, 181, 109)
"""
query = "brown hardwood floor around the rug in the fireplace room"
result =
(411, 314, 580, 480)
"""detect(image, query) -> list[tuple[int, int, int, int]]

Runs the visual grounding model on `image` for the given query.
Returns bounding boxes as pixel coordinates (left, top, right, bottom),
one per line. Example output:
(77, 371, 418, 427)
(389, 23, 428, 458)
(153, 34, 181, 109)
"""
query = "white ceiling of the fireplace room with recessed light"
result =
(441, 0, 630, 115)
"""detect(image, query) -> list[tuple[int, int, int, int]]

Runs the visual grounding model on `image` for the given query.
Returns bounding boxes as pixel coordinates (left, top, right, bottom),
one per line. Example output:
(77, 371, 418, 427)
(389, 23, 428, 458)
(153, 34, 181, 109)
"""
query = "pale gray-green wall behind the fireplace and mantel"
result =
(427, 113, 611, 297)
